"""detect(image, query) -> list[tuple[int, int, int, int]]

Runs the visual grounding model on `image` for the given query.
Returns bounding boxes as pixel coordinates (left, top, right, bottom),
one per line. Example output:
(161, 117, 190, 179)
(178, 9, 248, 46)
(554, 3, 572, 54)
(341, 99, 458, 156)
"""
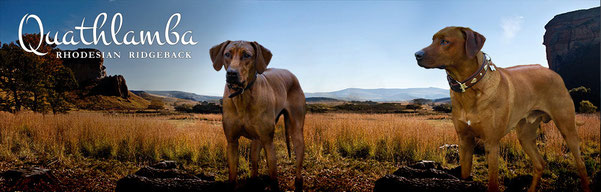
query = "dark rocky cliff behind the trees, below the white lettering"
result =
(62, 48, 129, 99)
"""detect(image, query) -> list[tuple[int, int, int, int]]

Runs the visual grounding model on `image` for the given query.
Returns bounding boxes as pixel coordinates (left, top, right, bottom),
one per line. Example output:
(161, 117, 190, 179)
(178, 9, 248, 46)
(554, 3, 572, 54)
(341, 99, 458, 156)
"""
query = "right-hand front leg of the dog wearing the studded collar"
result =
(484, 139, 499, 192)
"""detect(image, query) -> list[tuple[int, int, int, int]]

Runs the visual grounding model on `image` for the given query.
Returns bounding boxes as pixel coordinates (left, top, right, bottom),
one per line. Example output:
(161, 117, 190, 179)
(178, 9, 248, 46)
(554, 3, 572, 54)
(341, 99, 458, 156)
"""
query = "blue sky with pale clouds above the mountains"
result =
(0, 0, 599, 95)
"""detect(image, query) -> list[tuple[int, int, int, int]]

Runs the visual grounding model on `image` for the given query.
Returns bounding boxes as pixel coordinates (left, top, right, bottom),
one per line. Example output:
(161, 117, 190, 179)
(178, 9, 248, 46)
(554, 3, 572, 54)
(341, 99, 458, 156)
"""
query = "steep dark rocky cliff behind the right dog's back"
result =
(543, 7, 601, 106)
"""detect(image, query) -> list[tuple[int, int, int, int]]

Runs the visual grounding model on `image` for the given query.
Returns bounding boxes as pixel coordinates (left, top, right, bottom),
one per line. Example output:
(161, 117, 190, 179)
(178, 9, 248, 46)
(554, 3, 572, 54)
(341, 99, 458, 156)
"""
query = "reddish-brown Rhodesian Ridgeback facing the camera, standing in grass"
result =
(210, 41, 306, 191)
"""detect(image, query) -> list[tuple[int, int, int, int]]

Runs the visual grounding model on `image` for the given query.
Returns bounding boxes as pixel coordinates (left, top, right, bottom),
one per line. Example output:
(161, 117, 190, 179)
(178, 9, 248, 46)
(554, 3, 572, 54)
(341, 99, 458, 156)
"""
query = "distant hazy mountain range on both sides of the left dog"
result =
(131, 87, 449, 102)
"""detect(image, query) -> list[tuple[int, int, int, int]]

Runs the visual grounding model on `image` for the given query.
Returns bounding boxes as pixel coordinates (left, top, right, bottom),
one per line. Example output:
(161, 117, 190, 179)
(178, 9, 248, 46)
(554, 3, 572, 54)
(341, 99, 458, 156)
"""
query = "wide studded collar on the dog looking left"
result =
(447, 52, 496, 93)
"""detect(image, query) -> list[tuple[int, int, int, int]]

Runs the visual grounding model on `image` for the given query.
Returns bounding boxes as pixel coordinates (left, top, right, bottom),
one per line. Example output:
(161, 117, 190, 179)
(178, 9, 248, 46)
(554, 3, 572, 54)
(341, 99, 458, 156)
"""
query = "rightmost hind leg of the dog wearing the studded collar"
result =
(551, 109, 591, 191)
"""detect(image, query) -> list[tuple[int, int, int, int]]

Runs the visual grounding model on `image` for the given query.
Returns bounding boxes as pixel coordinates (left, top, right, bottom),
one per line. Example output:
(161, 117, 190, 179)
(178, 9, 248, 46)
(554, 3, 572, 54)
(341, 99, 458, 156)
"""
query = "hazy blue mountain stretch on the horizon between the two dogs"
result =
(305, 87, 449, 102)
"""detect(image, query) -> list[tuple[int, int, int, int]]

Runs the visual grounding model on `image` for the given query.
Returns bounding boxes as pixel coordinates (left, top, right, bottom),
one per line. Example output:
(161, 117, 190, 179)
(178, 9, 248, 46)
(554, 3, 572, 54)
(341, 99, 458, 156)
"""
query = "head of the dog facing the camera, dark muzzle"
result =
(210, 40, 272, 89)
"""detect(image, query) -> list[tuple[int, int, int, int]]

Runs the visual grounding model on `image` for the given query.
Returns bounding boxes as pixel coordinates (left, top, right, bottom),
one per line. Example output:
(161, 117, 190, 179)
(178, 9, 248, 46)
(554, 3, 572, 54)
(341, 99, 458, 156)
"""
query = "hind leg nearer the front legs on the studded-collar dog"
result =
(516, 117, 545, 192)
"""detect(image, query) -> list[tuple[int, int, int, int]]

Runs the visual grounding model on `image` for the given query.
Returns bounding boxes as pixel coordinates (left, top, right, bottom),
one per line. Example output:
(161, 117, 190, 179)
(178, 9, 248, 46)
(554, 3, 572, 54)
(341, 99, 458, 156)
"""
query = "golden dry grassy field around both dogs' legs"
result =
(0, 112, 601, 191)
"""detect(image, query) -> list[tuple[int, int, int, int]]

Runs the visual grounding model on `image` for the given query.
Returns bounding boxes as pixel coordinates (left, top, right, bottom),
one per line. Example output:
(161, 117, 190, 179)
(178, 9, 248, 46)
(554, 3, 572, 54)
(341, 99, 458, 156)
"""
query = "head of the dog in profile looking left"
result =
(415, 27, 486, 69)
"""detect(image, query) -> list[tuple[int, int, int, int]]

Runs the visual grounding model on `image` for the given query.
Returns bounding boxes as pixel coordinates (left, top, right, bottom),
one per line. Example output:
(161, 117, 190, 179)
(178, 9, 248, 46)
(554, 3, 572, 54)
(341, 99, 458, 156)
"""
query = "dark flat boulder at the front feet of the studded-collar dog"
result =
(374, 161, 486, 192)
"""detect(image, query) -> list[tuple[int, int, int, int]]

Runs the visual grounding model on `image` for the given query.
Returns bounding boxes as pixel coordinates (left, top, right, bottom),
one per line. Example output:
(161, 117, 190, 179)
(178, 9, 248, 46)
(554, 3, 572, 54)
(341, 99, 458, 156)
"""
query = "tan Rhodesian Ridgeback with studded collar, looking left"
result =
(415, 27, 590, 191)
